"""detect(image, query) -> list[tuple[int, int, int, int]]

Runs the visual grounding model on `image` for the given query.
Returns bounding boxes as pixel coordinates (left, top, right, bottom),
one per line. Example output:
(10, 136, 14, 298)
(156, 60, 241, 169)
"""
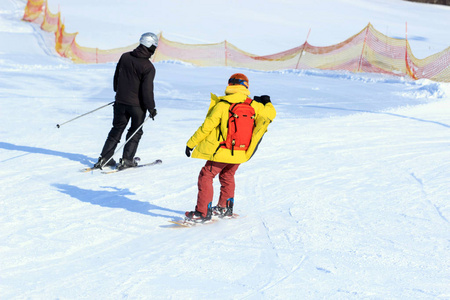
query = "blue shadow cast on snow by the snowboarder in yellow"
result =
(53, 184, 184, 219)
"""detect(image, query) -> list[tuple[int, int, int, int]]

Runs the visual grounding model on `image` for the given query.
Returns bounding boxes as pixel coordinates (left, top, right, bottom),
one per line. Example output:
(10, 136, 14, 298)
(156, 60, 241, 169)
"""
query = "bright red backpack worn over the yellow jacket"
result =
(220, 98, 255, 155)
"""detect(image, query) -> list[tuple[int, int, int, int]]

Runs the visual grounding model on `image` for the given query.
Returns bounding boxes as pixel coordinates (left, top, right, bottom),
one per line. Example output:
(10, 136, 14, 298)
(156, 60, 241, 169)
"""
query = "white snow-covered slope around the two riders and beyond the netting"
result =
(0, 0, 450, 299)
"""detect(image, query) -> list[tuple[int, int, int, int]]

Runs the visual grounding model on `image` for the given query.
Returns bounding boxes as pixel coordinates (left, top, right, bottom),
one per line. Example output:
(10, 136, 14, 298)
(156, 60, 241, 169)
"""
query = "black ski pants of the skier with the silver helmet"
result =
(100, 103, 145, 161)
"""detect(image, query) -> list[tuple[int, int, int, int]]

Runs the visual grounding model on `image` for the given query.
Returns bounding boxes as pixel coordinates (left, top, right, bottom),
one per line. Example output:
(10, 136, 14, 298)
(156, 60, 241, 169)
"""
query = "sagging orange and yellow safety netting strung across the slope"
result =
(23, 0, 450, 82)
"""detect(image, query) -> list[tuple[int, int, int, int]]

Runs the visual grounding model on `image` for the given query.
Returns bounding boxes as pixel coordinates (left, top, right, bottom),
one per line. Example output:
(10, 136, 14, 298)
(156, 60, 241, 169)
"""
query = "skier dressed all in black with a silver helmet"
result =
(94, 32, 158, 169)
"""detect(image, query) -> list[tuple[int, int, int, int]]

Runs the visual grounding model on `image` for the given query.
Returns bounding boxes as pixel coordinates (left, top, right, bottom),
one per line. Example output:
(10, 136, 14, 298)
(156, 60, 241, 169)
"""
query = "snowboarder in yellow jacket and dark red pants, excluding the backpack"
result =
(185, 73, 276, 222)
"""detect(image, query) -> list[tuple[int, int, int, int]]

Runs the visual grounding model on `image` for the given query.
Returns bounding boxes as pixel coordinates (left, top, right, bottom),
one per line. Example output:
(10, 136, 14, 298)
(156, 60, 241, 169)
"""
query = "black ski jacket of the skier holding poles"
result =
(114, 45, 155, 110)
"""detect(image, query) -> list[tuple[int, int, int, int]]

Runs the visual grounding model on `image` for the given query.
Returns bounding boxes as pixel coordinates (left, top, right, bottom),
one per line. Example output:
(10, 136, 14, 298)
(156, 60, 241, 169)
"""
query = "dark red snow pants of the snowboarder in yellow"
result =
(195, 160, 239, 217)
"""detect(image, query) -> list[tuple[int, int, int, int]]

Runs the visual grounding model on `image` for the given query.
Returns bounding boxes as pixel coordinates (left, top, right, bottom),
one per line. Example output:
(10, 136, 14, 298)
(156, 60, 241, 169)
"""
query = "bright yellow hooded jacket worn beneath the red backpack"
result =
(187, 85, 276, 164)
